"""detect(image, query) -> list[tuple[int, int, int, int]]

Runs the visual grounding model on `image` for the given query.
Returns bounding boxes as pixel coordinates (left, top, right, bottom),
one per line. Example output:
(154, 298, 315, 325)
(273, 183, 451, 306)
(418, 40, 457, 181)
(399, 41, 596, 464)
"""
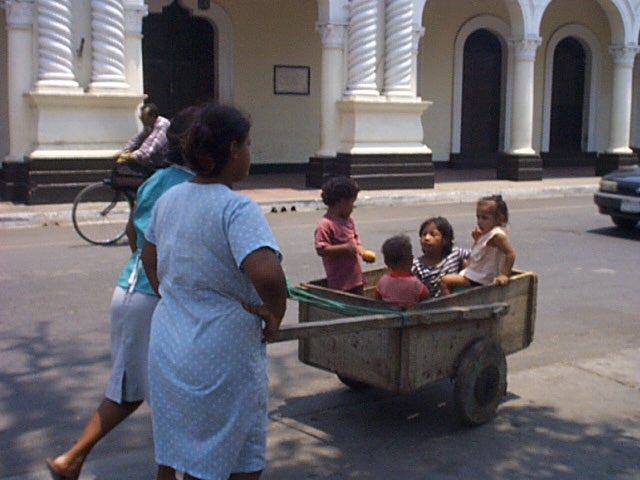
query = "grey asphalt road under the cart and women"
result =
(0, 195, 640, 480)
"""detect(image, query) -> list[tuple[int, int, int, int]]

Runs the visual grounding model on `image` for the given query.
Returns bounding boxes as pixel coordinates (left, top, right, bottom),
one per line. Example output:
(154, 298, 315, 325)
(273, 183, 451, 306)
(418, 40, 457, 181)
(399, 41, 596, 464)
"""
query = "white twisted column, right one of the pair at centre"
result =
(383, 0, 414, 97)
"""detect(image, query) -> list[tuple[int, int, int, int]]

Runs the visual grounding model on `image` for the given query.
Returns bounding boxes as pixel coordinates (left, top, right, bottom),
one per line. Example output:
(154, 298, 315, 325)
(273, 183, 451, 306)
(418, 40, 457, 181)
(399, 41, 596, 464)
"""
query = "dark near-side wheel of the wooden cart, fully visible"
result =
(453, 338, 507, 426)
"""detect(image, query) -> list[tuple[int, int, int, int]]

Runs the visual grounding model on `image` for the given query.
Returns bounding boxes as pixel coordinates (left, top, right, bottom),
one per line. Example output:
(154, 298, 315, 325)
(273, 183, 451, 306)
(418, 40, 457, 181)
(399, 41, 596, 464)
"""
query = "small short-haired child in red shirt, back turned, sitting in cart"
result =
(374, 235, 429, 309)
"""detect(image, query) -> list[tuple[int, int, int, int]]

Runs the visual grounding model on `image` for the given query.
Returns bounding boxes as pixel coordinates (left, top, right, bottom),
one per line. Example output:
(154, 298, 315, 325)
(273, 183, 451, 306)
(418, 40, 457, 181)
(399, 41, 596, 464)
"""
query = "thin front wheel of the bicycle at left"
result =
(71, 183, 133, 245)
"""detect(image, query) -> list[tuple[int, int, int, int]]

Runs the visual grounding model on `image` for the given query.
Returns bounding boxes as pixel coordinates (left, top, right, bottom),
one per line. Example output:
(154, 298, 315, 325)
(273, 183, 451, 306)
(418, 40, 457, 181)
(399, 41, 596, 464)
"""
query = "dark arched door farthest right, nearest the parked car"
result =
(549, 37, 586, 157)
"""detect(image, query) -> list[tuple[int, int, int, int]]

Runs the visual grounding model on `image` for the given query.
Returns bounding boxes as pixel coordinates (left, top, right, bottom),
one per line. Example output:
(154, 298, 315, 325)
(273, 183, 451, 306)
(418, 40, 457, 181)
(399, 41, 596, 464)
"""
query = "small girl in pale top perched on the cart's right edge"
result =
(440, 195, 516, 295)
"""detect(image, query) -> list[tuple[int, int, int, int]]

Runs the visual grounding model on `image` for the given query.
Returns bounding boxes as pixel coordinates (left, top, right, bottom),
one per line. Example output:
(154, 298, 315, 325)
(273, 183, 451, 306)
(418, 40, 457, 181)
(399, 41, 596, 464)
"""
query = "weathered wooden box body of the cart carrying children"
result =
(298, 268, 537, 393)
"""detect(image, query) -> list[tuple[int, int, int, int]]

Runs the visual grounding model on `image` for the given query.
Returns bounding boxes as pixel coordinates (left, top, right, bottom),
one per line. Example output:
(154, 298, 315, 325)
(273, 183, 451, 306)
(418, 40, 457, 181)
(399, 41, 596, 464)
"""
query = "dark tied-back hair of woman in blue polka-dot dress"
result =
(183, 103, 251, 177)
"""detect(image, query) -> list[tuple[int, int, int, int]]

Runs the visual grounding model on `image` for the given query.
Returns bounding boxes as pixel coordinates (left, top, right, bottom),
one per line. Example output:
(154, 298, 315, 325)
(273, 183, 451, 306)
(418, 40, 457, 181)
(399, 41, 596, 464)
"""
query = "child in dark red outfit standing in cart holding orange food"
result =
(314, 177, 376, 295)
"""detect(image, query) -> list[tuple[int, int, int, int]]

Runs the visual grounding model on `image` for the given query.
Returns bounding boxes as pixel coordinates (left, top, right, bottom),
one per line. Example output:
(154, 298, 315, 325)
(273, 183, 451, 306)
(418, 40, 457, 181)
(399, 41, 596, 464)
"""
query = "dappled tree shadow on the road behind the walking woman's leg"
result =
(0, 321, 153, 478)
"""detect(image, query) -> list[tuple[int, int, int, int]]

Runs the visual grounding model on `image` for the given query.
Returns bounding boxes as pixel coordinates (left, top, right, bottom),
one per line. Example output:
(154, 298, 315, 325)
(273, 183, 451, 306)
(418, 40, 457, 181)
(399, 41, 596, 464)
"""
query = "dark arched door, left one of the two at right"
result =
(457, 29, 502, 167)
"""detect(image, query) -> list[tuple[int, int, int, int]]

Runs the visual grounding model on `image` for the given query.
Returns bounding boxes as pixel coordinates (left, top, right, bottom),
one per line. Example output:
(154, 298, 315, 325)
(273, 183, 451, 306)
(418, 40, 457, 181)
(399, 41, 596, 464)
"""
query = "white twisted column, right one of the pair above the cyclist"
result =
(89, 0, 129, 91)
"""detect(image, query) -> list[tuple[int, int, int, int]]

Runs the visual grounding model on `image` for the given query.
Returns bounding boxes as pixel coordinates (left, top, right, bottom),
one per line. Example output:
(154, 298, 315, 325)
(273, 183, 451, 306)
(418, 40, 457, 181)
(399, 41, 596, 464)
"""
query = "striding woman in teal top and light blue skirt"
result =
(47, 107, 197, 480)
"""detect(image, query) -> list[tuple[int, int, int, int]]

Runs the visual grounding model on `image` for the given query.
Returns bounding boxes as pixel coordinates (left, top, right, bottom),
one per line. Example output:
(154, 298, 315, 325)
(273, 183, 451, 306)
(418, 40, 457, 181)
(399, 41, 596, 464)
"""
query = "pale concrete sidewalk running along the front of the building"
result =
(0, 167, 599, 227)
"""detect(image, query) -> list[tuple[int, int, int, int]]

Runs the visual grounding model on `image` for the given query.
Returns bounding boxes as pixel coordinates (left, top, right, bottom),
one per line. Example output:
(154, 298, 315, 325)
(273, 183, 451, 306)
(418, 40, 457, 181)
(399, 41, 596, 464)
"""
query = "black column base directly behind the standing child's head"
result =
(306, 153, 435, 190)
